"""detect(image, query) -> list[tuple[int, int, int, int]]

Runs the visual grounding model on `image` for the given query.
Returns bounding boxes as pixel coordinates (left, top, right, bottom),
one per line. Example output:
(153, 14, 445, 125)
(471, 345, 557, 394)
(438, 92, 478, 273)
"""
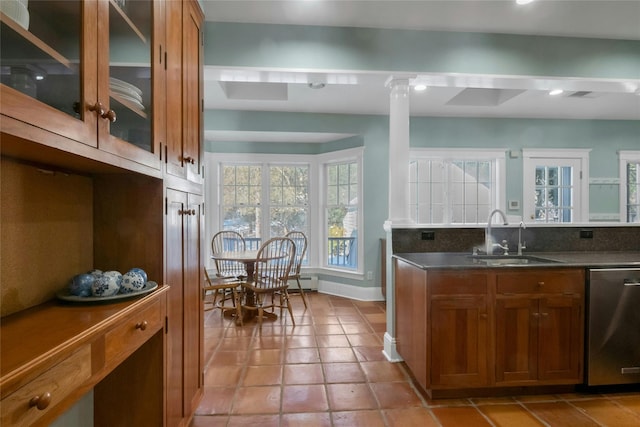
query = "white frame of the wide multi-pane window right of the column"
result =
(407, 147, 507, 226)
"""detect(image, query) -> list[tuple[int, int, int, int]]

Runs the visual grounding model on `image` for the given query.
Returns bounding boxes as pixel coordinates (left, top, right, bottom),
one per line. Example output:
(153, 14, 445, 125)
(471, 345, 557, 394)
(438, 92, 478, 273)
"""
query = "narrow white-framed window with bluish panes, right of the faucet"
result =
(523, 149, 589, 223)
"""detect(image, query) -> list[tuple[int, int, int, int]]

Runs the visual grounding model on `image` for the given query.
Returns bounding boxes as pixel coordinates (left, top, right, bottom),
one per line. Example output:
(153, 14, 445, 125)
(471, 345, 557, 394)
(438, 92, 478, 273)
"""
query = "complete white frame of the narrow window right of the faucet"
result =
(522, 148, 591, 225)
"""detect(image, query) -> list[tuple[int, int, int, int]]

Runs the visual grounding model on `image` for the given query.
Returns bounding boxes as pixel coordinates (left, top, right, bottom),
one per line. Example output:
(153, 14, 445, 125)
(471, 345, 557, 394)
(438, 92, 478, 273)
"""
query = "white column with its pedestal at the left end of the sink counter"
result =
(383, 77, 413, 362)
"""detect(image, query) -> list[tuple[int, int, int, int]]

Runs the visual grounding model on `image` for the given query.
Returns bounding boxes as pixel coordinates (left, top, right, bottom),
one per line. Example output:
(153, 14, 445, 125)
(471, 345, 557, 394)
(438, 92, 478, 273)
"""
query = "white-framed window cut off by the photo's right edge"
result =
(619, 151, 640, 223)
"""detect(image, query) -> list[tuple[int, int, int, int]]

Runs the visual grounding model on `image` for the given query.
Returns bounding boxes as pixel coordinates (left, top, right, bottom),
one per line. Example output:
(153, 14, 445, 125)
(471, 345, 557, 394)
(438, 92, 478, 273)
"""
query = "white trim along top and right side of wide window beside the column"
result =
(407, 148, 507, 226)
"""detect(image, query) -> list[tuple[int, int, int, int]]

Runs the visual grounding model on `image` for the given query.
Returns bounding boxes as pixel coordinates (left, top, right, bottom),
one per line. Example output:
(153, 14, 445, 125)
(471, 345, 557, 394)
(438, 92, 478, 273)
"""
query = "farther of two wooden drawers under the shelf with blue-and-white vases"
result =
(105, 298, 162, 364)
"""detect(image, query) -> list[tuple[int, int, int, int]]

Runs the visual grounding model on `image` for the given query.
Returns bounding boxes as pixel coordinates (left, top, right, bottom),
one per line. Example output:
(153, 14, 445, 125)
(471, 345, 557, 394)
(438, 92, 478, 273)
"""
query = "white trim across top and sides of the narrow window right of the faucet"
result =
(522, 148, 591, 223)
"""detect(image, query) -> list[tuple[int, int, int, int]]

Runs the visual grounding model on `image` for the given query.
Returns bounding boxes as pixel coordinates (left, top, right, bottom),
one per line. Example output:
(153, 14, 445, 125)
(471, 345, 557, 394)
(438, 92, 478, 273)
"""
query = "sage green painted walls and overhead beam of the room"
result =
(204, 22, 640, 286)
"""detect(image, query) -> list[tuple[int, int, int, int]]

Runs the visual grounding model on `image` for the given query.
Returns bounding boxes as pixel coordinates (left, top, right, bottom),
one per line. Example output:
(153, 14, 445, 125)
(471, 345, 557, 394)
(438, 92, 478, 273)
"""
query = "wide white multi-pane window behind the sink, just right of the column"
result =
(409, 149, 505, 224)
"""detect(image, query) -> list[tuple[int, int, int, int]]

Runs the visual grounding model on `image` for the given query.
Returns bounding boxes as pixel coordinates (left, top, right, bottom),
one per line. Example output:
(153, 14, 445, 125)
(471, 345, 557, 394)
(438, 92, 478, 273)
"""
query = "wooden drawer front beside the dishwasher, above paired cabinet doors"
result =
(496, 270, 584, 294)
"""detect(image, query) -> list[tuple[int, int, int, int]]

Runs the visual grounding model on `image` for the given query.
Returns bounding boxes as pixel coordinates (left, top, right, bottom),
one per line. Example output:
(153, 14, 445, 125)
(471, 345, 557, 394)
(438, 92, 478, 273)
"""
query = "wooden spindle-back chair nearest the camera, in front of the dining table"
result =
(242, 237, 296, 327)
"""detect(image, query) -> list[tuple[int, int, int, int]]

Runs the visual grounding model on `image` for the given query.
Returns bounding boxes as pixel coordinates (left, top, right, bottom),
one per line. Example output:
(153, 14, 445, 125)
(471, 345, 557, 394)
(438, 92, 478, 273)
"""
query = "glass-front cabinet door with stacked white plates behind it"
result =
(98, 0, 162, 167)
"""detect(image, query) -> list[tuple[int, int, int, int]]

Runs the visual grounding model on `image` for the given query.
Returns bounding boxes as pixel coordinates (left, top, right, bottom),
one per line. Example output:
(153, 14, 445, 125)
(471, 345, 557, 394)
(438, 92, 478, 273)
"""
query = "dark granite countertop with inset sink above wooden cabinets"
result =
(393, 252, 640, 269)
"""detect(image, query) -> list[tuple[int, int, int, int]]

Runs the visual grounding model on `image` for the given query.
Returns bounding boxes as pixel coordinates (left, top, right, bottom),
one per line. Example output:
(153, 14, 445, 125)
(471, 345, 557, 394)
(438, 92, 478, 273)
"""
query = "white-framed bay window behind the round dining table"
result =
(210, 148, 363, 276)
